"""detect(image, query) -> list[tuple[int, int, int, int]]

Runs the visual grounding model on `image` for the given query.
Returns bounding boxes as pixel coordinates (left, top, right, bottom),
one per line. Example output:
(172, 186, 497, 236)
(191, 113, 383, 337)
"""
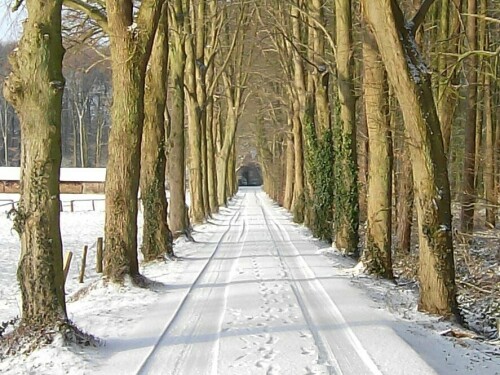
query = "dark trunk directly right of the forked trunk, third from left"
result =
(140, 4, 173, 261)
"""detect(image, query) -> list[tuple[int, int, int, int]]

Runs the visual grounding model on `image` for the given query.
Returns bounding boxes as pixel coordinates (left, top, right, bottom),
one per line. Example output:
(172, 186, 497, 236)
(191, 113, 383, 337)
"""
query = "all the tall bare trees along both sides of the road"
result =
(4, 0, 500, 338)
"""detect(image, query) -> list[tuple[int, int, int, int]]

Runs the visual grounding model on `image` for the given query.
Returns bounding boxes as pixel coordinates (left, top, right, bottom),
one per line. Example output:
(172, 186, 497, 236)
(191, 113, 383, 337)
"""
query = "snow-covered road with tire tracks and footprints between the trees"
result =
(95, 188, 500, 375)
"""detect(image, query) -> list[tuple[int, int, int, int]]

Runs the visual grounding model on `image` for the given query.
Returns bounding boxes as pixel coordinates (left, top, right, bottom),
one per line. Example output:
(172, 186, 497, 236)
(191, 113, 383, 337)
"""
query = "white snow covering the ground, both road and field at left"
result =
(0, 188, 500, 375)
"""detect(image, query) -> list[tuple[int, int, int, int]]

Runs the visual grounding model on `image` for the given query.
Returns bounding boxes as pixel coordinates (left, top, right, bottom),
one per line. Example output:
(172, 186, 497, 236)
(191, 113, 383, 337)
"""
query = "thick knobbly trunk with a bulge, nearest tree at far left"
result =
(4, 0, 67, 331)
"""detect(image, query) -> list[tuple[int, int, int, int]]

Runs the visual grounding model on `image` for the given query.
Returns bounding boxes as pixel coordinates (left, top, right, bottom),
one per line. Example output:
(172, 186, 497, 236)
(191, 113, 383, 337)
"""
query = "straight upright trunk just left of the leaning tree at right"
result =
(362, 22, 394, 279)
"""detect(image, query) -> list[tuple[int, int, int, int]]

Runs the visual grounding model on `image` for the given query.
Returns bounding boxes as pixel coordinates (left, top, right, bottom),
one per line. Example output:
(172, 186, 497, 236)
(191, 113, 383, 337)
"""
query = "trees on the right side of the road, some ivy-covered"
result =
(257, 0, 500, 319)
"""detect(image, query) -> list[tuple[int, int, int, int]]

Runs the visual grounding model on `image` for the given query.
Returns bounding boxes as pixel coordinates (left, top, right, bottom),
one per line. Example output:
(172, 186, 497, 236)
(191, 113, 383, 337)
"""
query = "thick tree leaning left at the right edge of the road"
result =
(362, 0, 459, 319)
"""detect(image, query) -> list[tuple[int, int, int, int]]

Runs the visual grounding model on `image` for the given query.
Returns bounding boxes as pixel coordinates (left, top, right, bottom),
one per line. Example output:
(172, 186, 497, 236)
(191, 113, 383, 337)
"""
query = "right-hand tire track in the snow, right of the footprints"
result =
(259, 197, 382, 375)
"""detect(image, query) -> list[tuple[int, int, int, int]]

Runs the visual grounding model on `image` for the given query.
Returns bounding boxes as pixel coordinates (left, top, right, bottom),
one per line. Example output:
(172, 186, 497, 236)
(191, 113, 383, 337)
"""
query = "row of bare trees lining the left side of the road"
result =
(3, 0, 255, 329)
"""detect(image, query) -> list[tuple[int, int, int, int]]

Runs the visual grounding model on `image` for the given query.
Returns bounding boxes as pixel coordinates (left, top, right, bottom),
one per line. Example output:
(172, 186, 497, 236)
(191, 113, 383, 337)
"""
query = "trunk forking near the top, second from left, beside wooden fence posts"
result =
(104, 0, 163, 282)
